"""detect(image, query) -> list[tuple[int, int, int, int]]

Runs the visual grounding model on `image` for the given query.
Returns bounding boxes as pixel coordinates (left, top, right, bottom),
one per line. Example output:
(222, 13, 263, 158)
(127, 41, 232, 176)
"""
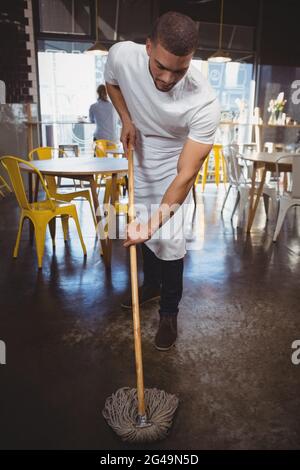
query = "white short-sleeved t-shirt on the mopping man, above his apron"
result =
(104, 41, 220, 144)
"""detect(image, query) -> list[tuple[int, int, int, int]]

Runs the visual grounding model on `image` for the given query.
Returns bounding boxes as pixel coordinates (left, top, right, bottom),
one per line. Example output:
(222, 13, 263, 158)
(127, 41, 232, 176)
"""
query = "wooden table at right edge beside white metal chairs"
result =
(243, 152, 292, 233)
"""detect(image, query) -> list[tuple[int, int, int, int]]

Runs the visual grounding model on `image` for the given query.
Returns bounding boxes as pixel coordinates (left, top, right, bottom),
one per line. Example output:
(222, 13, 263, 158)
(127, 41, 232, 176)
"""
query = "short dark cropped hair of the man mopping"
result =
(150, 11, 198, 56)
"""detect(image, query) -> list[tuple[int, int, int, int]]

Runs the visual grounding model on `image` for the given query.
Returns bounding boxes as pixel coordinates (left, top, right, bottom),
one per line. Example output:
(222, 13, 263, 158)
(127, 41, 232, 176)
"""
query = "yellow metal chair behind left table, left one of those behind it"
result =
(28, 147, 97, 227)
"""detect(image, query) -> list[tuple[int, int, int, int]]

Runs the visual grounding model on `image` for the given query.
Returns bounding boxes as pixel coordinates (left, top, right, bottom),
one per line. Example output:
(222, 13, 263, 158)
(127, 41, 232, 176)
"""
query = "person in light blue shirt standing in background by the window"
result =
(89, 85, 117, 142)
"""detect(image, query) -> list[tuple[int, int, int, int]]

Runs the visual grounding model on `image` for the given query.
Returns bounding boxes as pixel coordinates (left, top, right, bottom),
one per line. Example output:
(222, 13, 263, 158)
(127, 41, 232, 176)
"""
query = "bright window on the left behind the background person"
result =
(38, 41, 112, 155)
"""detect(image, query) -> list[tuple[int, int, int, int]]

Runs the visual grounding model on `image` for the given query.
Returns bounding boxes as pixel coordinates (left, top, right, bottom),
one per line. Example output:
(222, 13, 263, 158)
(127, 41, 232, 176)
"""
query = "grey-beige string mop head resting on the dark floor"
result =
(102, 387, 179, 442)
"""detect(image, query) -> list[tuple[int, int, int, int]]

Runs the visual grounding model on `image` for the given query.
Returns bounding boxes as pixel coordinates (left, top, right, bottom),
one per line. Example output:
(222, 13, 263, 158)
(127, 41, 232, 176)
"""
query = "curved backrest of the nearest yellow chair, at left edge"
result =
(0, 156, 55, 210)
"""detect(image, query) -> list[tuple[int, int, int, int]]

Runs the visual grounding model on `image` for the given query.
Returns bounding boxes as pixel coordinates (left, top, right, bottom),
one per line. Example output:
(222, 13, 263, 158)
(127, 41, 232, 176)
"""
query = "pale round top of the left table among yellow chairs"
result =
(20, 157, 128, 176)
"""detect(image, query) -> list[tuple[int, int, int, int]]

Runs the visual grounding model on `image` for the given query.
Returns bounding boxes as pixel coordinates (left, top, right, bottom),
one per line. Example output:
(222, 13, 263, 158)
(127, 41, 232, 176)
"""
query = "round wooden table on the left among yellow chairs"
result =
(21, 157, 128, 267)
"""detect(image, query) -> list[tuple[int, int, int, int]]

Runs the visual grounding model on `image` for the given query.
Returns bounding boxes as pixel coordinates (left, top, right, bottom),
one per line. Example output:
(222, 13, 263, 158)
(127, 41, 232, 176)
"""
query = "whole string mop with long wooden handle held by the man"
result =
(102, 149, 179, 443)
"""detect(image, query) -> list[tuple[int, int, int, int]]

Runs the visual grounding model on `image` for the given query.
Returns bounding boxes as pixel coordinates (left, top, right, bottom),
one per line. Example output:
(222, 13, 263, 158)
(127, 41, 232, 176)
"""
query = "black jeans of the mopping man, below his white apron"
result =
(141, 243, 183, 315)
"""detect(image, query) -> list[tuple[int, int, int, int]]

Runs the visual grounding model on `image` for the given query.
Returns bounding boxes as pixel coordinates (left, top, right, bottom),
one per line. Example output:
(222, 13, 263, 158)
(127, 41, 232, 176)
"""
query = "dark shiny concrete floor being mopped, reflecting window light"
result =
(0, 185, 300, 450)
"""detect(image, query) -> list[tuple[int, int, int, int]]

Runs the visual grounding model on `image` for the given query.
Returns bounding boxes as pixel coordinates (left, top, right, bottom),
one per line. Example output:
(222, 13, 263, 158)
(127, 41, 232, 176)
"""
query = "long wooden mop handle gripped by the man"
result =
(128, 148, 146, 416)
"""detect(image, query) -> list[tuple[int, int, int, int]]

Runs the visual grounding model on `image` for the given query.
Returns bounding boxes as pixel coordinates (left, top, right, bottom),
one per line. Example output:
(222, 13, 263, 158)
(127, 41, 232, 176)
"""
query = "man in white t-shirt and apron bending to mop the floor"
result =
(105, 12, 220, 351)
